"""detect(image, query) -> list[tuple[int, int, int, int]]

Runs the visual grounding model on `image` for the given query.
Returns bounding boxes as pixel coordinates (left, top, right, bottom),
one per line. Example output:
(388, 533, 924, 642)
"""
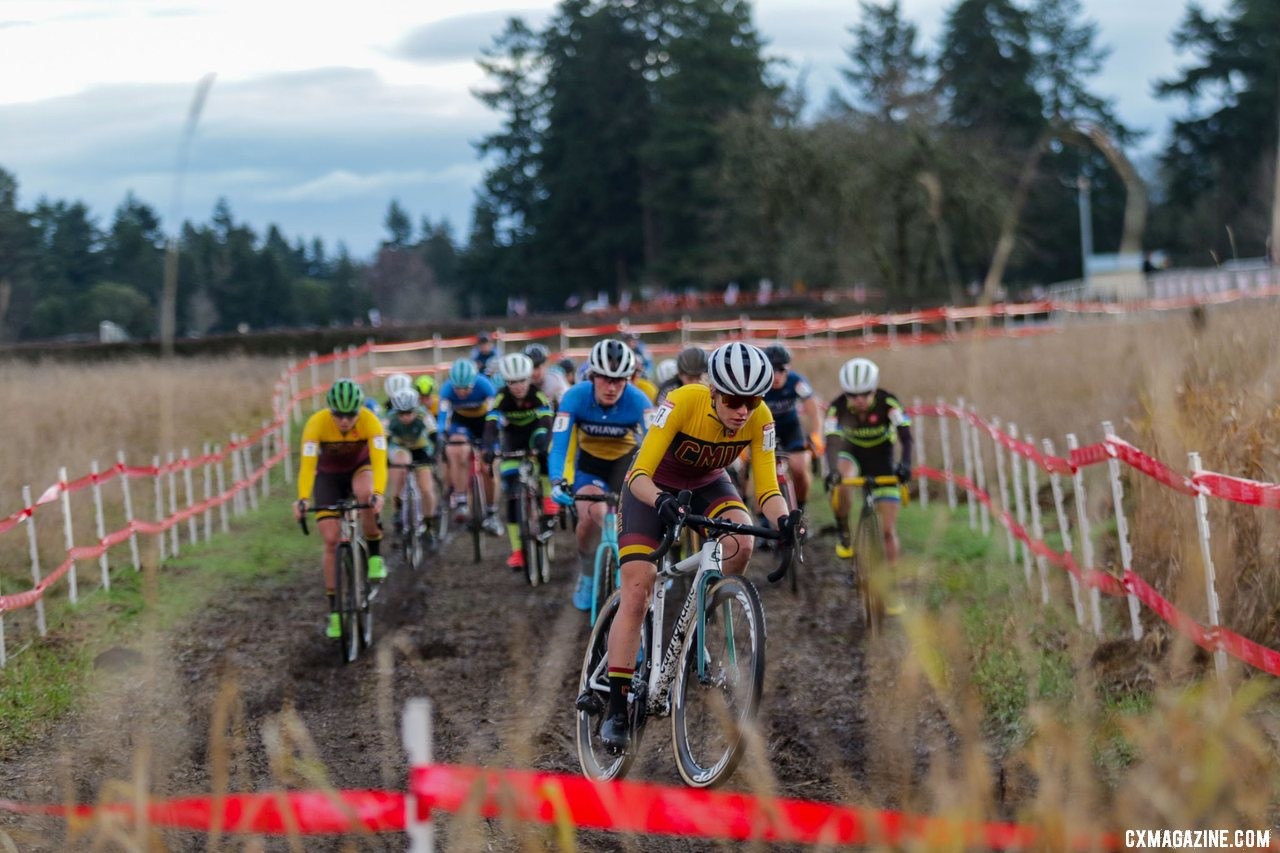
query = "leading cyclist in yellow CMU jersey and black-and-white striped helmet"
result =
(600, 342, 800, 749)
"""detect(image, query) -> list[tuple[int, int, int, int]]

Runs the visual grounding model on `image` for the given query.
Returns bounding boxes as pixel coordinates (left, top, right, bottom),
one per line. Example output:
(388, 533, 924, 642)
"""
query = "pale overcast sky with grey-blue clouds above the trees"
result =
(0, 0, 1226, 257)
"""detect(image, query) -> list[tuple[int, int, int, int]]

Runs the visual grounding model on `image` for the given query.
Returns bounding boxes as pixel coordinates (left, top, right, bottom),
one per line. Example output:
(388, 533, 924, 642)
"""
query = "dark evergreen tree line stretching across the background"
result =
(0, 0, 1280, 341)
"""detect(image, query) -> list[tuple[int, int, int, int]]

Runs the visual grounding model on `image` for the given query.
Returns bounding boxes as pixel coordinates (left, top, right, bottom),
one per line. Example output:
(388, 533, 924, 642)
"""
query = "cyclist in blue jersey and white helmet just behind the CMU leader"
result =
(549, 339, 650, 611)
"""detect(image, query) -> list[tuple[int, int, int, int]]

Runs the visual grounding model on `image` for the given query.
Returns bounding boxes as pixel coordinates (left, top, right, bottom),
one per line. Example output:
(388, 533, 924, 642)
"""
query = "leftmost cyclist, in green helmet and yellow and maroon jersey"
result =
(293, 379, 387, 638)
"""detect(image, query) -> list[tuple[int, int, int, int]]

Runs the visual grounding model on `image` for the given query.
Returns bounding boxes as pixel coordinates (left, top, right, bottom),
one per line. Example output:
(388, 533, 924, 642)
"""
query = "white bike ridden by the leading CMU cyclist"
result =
(575, 492, 803, 788)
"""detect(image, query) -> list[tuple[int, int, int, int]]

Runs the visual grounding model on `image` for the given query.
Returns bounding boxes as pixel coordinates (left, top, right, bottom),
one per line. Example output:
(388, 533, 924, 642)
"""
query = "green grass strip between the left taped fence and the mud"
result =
(0, 488, 303, 758)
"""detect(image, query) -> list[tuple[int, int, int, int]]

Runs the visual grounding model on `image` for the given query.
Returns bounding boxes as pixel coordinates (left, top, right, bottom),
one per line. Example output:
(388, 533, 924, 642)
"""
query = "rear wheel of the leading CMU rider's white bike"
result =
(573, 593, 653, 781)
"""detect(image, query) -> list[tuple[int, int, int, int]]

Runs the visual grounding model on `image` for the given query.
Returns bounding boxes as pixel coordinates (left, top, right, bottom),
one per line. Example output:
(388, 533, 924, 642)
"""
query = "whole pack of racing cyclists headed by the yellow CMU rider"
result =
(294, 333, 913, 650)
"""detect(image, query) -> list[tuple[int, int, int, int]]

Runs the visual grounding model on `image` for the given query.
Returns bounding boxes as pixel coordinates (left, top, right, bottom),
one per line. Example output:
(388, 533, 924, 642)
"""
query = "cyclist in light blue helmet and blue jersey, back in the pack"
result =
(440, 359, 502, 537)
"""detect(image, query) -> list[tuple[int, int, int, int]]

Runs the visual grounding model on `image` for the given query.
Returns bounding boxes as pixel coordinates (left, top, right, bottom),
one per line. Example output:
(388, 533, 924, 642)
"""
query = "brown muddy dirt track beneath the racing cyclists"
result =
(0, 507, 952, 850)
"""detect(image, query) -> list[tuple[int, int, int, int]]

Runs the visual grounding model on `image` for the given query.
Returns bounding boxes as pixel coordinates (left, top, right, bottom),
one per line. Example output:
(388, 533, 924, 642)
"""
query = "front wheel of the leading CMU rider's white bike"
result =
(671, 575, 764, 788)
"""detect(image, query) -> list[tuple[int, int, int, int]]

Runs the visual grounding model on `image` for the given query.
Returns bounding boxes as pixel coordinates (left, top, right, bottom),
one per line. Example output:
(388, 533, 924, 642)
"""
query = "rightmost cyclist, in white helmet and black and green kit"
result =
(823, 359, 911, 601)
